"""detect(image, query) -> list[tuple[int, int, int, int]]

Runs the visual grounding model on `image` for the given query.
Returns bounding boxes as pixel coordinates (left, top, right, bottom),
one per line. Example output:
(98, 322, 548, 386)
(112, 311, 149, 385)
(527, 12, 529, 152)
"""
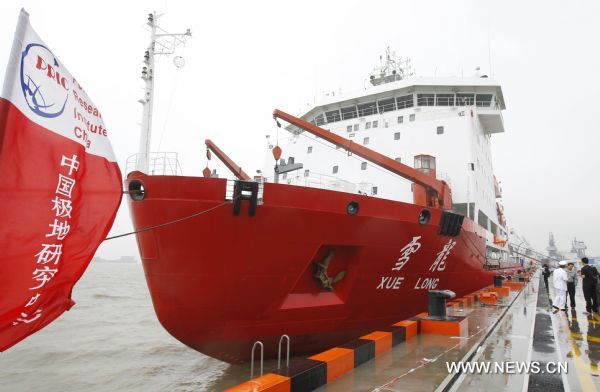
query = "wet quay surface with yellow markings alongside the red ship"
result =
(216, 272, 600, 392)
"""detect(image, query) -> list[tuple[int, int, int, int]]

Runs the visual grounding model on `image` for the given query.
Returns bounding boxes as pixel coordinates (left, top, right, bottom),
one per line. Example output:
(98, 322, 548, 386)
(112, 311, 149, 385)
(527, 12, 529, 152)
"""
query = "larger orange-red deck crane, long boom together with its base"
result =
(273, 109, 452, 210)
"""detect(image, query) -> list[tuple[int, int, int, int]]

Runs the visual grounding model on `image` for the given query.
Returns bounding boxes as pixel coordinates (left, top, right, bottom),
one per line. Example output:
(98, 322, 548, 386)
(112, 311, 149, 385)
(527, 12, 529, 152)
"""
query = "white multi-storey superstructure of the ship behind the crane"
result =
(265, 49, 508, 264)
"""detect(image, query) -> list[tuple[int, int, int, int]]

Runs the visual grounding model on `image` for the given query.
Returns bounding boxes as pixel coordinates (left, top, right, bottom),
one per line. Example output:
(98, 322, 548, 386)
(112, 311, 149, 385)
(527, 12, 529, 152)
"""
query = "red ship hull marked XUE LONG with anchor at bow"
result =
(128, 172, 516, 363)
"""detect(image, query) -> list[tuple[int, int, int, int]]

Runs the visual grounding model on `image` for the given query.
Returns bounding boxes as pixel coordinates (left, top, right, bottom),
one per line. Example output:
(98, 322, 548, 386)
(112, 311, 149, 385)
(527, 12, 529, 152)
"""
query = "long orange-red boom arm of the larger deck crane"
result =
(273, 109, 452, 209)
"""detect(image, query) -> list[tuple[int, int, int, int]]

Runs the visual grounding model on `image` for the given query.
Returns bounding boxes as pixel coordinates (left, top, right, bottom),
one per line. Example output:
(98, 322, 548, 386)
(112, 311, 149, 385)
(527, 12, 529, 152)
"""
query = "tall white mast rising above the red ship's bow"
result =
(136, 12, 192, 173)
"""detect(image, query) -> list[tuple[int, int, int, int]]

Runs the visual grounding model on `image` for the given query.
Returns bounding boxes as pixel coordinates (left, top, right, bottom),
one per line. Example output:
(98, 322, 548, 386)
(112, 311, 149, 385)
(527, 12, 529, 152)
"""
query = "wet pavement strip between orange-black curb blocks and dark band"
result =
(318, 283, 537, 391)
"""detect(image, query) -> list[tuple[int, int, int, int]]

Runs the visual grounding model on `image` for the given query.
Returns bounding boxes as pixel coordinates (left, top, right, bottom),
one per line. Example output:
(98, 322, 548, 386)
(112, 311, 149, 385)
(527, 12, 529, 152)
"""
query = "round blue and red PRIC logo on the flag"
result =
(20, 43, 69, 118)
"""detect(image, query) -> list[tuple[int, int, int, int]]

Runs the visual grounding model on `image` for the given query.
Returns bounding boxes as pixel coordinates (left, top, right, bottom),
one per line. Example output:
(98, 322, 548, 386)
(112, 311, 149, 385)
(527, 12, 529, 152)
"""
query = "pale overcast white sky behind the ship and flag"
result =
(0, 0, 600, 258)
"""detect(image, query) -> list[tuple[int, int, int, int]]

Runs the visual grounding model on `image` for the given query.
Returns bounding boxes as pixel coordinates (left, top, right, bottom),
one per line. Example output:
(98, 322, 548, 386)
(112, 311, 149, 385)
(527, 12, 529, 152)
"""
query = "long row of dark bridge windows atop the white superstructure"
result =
(311, 93, 494, 125)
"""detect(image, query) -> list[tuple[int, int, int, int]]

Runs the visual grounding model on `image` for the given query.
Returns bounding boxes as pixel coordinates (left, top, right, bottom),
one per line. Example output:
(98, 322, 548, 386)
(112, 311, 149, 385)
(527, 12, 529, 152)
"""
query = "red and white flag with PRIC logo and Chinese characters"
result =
(0, 11, 122, 351)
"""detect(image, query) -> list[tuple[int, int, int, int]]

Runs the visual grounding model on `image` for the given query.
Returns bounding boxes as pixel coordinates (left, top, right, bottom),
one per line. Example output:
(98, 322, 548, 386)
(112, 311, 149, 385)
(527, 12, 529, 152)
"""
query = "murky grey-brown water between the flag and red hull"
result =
(0, 262, 258, 392)
